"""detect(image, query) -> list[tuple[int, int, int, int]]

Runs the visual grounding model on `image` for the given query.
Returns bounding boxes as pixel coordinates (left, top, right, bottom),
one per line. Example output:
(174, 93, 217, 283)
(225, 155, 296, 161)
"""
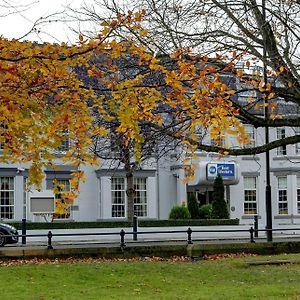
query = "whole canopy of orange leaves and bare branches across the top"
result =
(0, 0, 300, 213)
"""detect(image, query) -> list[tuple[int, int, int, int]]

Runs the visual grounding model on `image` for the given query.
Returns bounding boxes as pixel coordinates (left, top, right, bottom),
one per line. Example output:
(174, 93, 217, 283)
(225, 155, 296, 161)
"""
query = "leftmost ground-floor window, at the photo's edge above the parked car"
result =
(0, 177, 15, 219)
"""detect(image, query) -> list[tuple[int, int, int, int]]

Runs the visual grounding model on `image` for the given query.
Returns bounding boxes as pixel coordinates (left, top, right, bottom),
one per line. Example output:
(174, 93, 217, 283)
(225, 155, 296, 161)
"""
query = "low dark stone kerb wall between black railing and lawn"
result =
(0, 241, 300, 259)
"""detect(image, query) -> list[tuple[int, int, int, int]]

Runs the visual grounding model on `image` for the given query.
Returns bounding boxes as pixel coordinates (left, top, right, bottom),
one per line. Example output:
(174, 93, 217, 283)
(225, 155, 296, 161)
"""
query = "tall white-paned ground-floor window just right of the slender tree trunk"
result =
(133, 178, 147, 217)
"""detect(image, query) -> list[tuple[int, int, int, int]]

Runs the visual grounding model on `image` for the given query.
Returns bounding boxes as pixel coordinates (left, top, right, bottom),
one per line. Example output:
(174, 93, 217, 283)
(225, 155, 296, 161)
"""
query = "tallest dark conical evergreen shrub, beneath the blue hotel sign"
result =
(212, 174, 229, 219)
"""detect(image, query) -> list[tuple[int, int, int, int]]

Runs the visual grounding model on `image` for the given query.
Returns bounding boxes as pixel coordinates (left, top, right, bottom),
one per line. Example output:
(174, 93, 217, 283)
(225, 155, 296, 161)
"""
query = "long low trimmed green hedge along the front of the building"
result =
(10, 219, 239, 230)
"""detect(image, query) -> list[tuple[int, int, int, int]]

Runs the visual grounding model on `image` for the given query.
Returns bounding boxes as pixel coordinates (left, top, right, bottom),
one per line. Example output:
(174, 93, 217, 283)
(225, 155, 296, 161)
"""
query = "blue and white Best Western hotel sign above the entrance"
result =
(206, 163, 236, 180)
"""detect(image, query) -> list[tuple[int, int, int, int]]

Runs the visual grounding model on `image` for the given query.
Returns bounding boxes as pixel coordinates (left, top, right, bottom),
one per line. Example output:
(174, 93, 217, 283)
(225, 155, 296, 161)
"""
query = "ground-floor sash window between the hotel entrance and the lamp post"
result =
(244, 177, 257, 215)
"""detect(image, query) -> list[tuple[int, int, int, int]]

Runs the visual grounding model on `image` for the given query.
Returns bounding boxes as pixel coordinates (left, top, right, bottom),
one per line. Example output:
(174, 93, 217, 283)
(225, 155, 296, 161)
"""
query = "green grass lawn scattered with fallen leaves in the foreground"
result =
(0, 254, 300, 300)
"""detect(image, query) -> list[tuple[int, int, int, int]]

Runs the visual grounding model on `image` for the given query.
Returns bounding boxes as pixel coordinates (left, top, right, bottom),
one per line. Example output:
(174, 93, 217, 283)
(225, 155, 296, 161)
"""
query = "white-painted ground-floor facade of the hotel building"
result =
(0, 128, 300, 226)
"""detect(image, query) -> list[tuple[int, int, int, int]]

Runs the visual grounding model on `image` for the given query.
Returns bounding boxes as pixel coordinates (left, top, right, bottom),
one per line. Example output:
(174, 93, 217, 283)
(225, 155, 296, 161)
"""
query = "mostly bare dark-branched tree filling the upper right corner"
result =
(73, 0, 300, 155)
